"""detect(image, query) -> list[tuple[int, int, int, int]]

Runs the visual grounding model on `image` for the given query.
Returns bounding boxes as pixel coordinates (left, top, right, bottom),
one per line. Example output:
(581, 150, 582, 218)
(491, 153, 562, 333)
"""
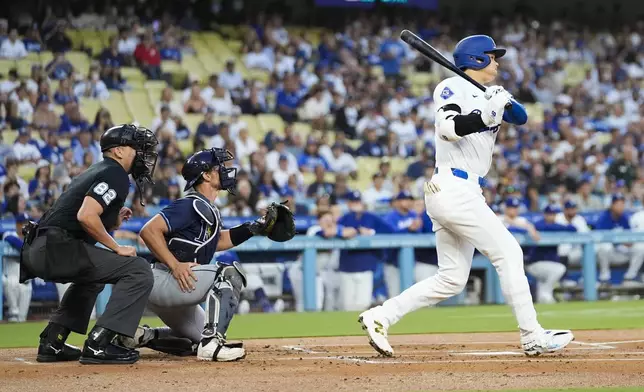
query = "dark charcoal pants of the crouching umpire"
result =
(28, 236, 153, 337)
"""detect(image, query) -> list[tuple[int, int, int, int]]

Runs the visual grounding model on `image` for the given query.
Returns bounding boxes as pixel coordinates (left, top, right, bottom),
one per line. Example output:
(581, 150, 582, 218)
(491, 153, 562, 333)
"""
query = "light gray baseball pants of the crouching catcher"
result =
(148, 263, 219, 343)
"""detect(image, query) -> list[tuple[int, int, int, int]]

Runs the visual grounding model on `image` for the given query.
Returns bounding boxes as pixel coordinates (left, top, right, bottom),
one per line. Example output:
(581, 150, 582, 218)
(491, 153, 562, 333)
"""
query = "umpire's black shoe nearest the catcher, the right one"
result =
(80, 326, 139, 365)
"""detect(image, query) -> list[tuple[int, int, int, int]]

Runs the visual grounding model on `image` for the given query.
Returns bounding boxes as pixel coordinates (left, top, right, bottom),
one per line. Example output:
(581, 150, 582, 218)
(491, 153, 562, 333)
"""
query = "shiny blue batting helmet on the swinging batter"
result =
(454, 35, 505, 70)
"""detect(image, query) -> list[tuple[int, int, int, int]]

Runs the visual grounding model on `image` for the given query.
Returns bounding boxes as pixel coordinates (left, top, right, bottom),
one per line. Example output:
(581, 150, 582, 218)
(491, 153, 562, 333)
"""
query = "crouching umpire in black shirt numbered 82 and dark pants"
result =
(21, 124, 158, 364)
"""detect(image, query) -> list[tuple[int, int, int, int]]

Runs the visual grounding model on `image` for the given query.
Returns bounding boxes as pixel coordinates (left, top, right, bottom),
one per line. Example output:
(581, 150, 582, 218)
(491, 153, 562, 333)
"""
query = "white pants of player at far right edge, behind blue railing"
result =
(597, 242, 644, 281)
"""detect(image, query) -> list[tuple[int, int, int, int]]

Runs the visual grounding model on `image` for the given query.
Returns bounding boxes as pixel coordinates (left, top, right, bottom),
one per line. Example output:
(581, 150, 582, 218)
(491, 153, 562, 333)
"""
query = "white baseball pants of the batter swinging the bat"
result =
(379, 168, 541, 333)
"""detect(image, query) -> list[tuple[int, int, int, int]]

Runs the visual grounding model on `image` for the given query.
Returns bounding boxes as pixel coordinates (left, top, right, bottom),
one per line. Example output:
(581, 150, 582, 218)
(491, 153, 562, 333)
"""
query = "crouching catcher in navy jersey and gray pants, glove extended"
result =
(119, 148, 295, 361)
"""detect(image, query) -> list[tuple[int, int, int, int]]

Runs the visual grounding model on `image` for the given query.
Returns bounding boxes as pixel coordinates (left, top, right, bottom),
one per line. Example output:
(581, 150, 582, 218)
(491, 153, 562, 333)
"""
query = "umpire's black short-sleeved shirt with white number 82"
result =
(39, 157, 130, 244)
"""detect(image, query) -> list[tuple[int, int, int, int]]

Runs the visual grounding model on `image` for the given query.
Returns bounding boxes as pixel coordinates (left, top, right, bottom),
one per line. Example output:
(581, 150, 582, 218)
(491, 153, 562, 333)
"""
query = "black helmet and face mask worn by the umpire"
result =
(100, 124, 159, 205)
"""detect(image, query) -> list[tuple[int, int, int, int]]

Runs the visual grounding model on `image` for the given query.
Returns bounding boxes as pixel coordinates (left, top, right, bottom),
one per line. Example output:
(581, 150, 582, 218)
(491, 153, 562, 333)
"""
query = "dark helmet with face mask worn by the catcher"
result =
(181, 148, 237, 194)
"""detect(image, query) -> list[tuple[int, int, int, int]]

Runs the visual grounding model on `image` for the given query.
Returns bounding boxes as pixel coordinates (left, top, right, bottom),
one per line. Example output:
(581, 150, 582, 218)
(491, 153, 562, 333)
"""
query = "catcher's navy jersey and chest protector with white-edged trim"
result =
(161, 192, 221, 264)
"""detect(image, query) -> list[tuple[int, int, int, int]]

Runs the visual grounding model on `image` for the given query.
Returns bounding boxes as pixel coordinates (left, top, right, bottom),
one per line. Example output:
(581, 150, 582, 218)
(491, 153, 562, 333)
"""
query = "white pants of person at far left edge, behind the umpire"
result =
(2, 257, 32, 322)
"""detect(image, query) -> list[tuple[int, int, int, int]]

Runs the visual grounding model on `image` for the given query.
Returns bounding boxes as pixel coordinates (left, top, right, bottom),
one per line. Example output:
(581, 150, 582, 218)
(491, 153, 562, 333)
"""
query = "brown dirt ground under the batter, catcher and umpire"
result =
(0, 330, 644, 392)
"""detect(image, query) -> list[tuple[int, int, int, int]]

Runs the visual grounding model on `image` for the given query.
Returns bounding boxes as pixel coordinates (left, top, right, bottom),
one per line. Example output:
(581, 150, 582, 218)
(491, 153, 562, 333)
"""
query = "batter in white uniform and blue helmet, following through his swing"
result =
(359, 35, 574, 356)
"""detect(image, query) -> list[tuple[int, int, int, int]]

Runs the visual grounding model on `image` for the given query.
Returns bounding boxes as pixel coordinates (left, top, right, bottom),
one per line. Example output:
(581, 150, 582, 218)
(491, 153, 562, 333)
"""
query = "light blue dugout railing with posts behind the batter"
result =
(0, 231, 644, 320)
